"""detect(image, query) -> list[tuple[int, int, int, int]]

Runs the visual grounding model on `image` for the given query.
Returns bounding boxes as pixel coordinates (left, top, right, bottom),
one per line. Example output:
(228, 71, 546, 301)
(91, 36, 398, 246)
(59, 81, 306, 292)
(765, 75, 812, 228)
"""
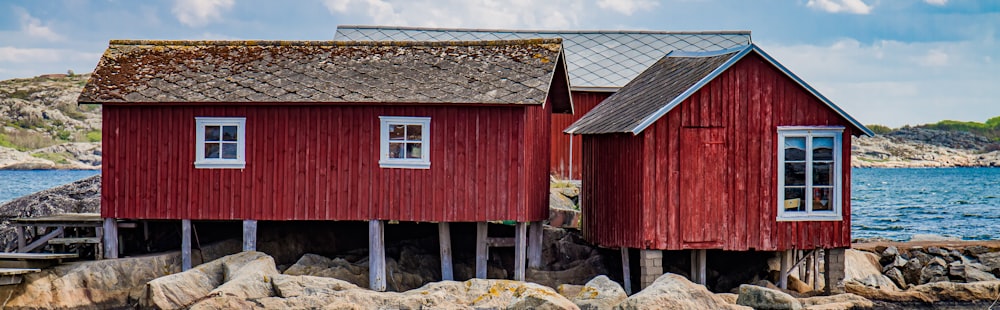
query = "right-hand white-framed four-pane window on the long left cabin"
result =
(378, 116, 431, 169)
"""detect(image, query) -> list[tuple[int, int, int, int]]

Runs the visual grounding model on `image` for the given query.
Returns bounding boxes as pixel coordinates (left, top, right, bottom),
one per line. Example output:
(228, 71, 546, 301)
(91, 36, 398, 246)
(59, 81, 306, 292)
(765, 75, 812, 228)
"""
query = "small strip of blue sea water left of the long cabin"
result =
(0, 170, 101, 204)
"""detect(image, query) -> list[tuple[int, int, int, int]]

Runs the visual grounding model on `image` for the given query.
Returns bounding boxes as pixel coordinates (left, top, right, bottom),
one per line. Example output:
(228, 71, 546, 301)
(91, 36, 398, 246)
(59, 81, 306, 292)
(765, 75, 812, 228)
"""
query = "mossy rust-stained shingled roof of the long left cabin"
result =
(78, 39, 571, 111)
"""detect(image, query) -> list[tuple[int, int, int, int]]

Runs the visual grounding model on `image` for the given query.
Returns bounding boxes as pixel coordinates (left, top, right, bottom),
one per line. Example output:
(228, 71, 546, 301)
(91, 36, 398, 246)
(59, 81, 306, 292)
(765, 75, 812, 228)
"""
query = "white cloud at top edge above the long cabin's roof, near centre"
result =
(324, 0, 584, 29)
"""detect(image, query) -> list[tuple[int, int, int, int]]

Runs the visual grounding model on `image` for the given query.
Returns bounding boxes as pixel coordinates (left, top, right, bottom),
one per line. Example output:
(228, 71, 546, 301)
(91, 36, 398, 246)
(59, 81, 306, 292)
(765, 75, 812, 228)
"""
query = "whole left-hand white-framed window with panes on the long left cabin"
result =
(194, 117, 247, 169)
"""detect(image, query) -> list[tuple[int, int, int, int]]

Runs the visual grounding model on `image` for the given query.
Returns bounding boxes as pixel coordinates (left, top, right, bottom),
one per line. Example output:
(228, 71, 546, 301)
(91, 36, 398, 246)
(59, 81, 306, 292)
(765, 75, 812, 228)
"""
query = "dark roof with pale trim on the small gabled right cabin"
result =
(565, 44, 874, 136)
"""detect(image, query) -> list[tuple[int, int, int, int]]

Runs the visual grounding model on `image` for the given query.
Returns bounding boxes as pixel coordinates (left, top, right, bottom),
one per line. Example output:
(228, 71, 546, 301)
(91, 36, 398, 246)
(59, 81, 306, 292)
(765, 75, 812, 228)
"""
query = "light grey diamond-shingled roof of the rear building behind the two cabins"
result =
(334, 25, 751, 91)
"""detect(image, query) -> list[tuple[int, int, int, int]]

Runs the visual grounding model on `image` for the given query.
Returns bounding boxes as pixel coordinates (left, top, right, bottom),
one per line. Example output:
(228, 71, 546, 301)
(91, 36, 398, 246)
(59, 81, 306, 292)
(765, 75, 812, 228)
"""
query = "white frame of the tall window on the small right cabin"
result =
(776, 126, 844, 222)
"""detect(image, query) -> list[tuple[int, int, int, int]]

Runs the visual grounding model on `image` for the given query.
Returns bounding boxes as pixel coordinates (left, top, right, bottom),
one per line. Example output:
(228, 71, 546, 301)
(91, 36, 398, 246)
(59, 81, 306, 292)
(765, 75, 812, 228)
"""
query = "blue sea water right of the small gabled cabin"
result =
(851, 168, 1000, 240)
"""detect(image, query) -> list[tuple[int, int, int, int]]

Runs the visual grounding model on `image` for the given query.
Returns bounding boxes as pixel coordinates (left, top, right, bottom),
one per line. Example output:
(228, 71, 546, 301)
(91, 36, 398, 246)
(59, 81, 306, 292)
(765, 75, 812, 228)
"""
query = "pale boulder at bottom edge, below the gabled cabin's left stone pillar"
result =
(615, 273, 752, 310)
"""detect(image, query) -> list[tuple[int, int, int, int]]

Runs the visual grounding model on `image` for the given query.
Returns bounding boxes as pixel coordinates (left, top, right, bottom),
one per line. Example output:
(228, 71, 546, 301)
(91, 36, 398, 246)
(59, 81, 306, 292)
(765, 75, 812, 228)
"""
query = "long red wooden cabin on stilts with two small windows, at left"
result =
(79, 39, 572, 289)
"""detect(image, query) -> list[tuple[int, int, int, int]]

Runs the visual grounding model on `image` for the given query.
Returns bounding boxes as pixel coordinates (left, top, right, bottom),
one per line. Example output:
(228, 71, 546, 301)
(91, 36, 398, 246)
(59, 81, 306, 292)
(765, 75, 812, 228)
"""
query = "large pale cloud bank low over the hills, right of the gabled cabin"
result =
(758, 39, 1000, 127)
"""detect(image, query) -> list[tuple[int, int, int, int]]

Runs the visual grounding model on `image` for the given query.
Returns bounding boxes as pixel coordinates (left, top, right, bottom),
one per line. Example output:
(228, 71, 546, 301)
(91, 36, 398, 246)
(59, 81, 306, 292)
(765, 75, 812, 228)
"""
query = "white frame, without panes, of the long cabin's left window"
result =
(194, 117, 247, 169)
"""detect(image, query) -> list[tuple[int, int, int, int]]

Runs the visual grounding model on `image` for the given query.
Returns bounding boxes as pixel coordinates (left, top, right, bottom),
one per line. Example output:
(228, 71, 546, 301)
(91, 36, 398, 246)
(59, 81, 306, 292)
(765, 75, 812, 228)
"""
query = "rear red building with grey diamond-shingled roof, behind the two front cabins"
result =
(334, 25, 750, 180)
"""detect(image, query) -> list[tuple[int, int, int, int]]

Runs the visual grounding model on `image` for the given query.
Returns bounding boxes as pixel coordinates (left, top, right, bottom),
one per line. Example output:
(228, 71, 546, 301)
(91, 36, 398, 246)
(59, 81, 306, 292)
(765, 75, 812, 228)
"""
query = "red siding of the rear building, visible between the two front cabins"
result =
(550, 91, 614, 180)
